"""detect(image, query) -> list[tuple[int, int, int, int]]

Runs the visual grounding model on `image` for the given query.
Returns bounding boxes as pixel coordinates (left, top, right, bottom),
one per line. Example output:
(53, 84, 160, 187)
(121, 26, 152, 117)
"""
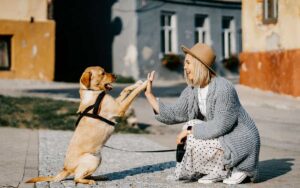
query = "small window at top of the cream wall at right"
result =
(263, 0, 278, 24)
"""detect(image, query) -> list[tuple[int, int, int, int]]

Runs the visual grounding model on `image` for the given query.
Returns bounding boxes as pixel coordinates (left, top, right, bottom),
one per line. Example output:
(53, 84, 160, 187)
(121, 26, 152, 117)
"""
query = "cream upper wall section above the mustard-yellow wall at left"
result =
(0, 0, 47, 21)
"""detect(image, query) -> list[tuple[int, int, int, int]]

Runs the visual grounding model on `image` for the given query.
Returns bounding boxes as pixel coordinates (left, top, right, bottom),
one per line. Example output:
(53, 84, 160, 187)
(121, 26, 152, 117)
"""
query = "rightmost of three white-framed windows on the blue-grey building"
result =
(222, 16, 236, 59)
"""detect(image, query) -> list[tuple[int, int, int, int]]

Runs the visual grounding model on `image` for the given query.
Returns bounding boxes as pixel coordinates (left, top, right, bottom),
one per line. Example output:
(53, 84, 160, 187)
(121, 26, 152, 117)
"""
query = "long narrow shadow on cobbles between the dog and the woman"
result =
(97, 161, 176, 181)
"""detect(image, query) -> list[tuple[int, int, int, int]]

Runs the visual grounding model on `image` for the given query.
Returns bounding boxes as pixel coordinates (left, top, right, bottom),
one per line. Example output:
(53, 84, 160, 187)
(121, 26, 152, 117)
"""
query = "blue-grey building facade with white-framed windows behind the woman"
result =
(112, 0, 241, 80)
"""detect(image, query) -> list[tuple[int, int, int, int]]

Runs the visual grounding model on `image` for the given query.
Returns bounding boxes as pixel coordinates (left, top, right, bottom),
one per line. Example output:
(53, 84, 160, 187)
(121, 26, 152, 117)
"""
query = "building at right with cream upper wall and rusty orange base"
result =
(240, 0, 300, 96)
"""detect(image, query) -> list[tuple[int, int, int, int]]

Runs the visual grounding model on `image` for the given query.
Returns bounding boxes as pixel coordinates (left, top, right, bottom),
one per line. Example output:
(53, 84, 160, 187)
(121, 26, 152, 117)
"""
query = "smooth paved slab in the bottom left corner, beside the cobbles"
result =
(0, 127, 39, 188)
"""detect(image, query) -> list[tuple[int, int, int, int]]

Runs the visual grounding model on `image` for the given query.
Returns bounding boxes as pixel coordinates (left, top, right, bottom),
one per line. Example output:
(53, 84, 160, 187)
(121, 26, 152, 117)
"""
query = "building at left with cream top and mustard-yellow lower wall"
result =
(0, 0, 55, 81)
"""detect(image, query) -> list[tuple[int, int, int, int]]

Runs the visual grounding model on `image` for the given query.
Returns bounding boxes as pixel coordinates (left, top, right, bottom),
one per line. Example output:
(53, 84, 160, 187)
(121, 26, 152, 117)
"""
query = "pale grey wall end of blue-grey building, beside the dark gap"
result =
(112, 0, 139, 79)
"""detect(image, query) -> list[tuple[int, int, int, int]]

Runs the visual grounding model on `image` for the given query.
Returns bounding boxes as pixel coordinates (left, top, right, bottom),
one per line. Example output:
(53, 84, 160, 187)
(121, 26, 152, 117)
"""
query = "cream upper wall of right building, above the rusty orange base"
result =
(242, 0, 300, 52)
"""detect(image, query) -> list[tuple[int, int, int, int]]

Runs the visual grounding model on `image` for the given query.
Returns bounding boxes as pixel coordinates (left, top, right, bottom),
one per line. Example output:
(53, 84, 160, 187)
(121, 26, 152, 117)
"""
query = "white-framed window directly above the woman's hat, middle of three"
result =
(195, 14, 210, 45)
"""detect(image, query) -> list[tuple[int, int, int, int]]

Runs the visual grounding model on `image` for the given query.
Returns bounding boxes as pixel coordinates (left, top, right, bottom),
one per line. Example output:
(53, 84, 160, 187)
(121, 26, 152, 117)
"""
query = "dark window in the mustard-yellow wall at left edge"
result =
(0, 35, 11, 70)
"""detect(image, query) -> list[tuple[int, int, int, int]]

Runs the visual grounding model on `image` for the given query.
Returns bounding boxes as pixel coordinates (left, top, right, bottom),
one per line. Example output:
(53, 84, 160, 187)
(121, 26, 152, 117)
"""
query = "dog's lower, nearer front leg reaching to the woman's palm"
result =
(119, 80, 148, 117)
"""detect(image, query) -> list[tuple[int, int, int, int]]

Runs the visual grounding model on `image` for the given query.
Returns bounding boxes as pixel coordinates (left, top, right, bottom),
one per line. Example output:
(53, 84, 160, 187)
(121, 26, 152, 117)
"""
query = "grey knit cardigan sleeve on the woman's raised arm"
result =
(155, 87, 190, 124)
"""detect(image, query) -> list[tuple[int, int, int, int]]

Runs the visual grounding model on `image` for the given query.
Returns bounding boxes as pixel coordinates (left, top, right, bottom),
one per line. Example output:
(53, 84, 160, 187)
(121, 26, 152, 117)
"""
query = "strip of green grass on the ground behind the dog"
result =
(0, 95, 146, 133)
